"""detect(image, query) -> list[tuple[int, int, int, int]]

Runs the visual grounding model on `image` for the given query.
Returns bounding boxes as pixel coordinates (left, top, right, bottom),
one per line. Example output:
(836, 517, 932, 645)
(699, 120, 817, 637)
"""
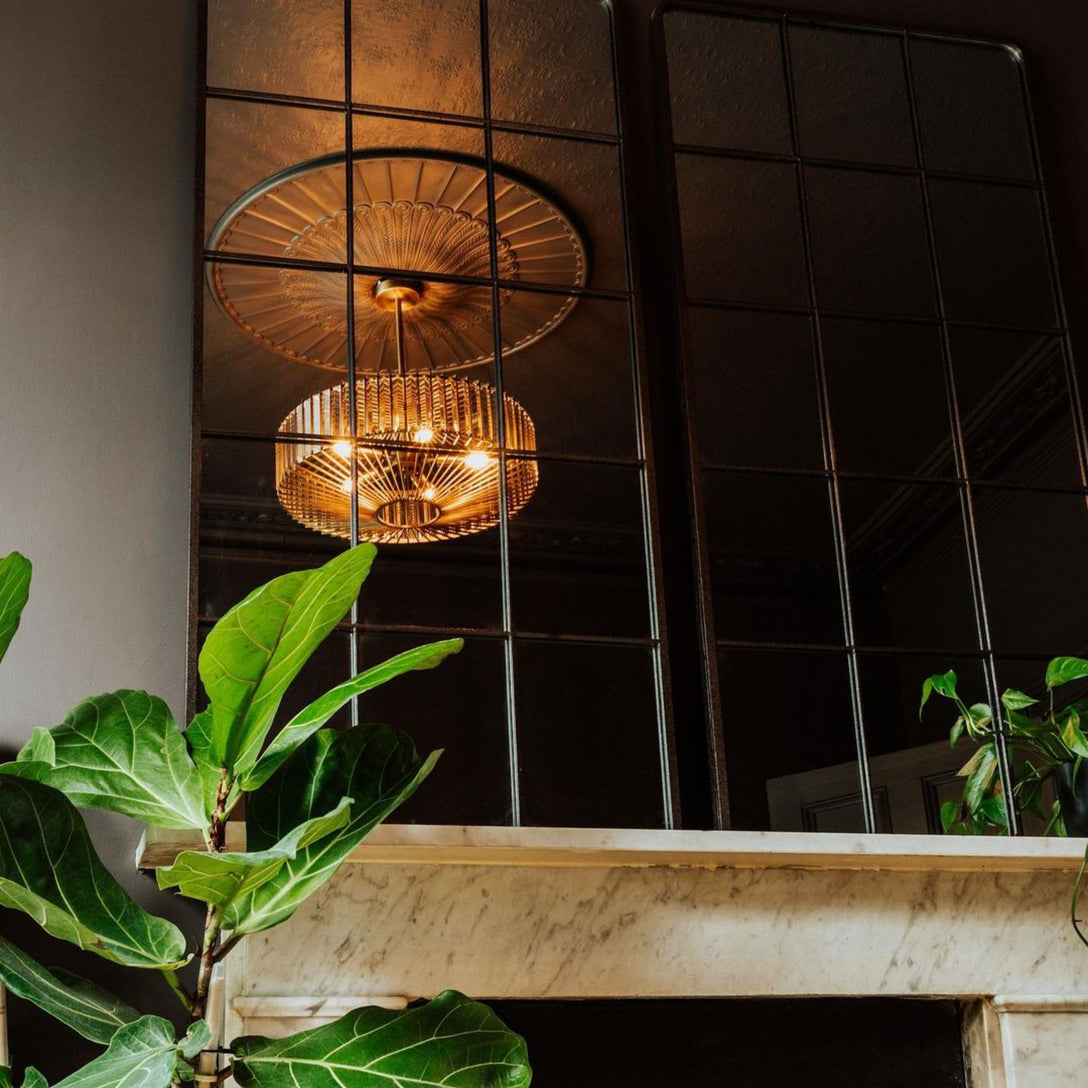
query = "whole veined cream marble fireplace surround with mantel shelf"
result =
(139, 825, 1088, 1088)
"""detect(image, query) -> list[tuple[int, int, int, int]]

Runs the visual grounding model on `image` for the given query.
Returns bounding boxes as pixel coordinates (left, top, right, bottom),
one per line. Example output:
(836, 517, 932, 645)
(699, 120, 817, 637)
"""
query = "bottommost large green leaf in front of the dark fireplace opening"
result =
(233, 990, 532, 1088)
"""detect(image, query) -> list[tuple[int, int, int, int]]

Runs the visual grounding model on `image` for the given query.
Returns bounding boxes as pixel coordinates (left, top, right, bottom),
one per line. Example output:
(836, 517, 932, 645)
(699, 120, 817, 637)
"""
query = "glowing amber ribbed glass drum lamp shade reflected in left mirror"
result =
(276, 371, 539, 544)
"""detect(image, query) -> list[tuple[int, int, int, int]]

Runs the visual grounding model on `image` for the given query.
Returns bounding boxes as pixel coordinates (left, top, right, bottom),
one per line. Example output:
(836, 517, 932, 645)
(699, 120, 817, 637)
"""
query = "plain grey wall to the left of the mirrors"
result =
(0, 0, 197, 1074)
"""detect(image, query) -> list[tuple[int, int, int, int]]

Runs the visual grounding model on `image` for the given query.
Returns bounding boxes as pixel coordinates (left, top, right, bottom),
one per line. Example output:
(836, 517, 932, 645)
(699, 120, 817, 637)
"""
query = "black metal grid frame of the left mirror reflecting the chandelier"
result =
(189, 0, 678, 827)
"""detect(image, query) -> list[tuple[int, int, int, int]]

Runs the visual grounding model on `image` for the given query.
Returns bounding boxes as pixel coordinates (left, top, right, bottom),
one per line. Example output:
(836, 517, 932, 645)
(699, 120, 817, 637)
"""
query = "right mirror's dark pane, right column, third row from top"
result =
(951, 329, 1080, 487)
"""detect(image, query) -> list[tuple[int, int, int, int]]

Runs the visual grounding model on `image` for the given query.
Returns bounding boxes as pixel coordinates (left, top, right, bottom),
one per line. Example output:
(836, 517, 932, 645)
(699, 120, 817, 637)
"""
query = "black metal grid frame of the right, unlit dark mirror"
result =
(653, 2, 1088, 834)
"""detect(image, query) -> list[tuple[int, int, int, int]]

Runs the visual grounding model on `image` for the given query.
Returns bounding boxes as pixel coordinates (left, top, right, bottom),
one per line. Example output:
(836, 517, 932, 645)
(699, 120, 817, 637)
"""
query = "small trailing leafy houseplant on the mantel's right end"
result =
(919, 657, 1088, 836)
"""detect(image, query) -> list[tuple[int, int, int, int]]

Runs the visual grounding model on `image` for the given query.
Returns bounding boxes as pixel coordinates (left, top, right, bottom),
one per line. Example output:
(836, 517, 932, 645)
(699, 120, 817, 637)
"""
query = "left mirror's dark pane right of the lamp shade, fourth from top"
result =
(510, 460, 650, 638)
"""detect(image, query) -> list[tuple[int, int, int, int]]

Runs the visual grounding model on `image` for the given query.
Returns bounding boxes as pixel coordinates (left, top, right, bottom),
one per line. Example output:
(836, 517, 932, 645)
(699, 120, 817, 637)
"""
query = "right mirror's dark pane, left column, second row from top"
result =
(677, 154, 808, 306)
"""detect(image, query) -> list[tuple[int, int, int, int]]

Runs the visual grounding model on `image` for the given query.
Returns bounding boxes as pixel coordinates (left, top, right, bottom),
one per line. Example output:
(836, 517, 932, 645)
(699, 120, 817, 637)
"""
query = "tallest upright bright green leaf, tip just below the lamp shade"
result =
(199, 544, 375, 771)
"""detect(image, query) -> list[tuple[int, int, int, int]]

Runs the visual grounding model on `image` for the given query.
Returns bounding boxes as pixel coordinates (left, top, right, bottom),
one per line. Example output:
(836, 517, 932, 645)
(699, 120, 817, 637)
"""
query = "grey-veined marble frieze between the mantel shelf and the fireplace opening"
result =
(225, 864, 1088, 997)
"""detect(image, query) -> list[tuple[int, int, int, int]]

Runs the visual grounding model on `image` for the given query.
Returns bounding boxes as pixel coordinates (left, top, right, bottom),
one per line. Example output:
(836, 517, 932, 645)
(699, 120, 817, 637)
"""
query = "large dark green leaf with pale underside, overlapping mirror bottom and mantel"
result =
(226, 726, 440, 935)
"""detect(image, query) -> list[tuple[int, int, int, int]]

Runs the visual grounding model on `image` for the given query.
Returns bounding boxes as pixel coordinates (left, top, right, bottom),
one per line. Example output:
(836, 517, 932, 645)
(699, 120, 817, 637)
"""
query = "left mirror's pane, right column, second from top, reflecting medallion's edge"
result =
(492, 132, 628, 290)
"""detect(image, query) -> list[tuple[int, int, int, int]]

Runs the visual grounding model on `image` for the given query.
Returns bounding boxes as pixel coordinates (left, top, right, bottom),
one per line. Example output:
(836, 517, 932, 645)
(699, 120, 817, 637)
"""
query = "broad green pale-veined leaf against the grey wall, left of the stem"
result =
(0, 691, 207, 828)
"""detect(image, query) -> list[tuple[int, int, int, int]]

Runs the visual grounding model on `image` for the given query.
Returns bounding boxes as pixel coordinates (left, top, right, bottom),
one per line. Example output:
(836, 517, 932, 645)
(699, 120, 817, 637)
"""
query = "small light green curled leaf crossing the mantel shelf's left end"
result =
(156, 798, 351, 911)
